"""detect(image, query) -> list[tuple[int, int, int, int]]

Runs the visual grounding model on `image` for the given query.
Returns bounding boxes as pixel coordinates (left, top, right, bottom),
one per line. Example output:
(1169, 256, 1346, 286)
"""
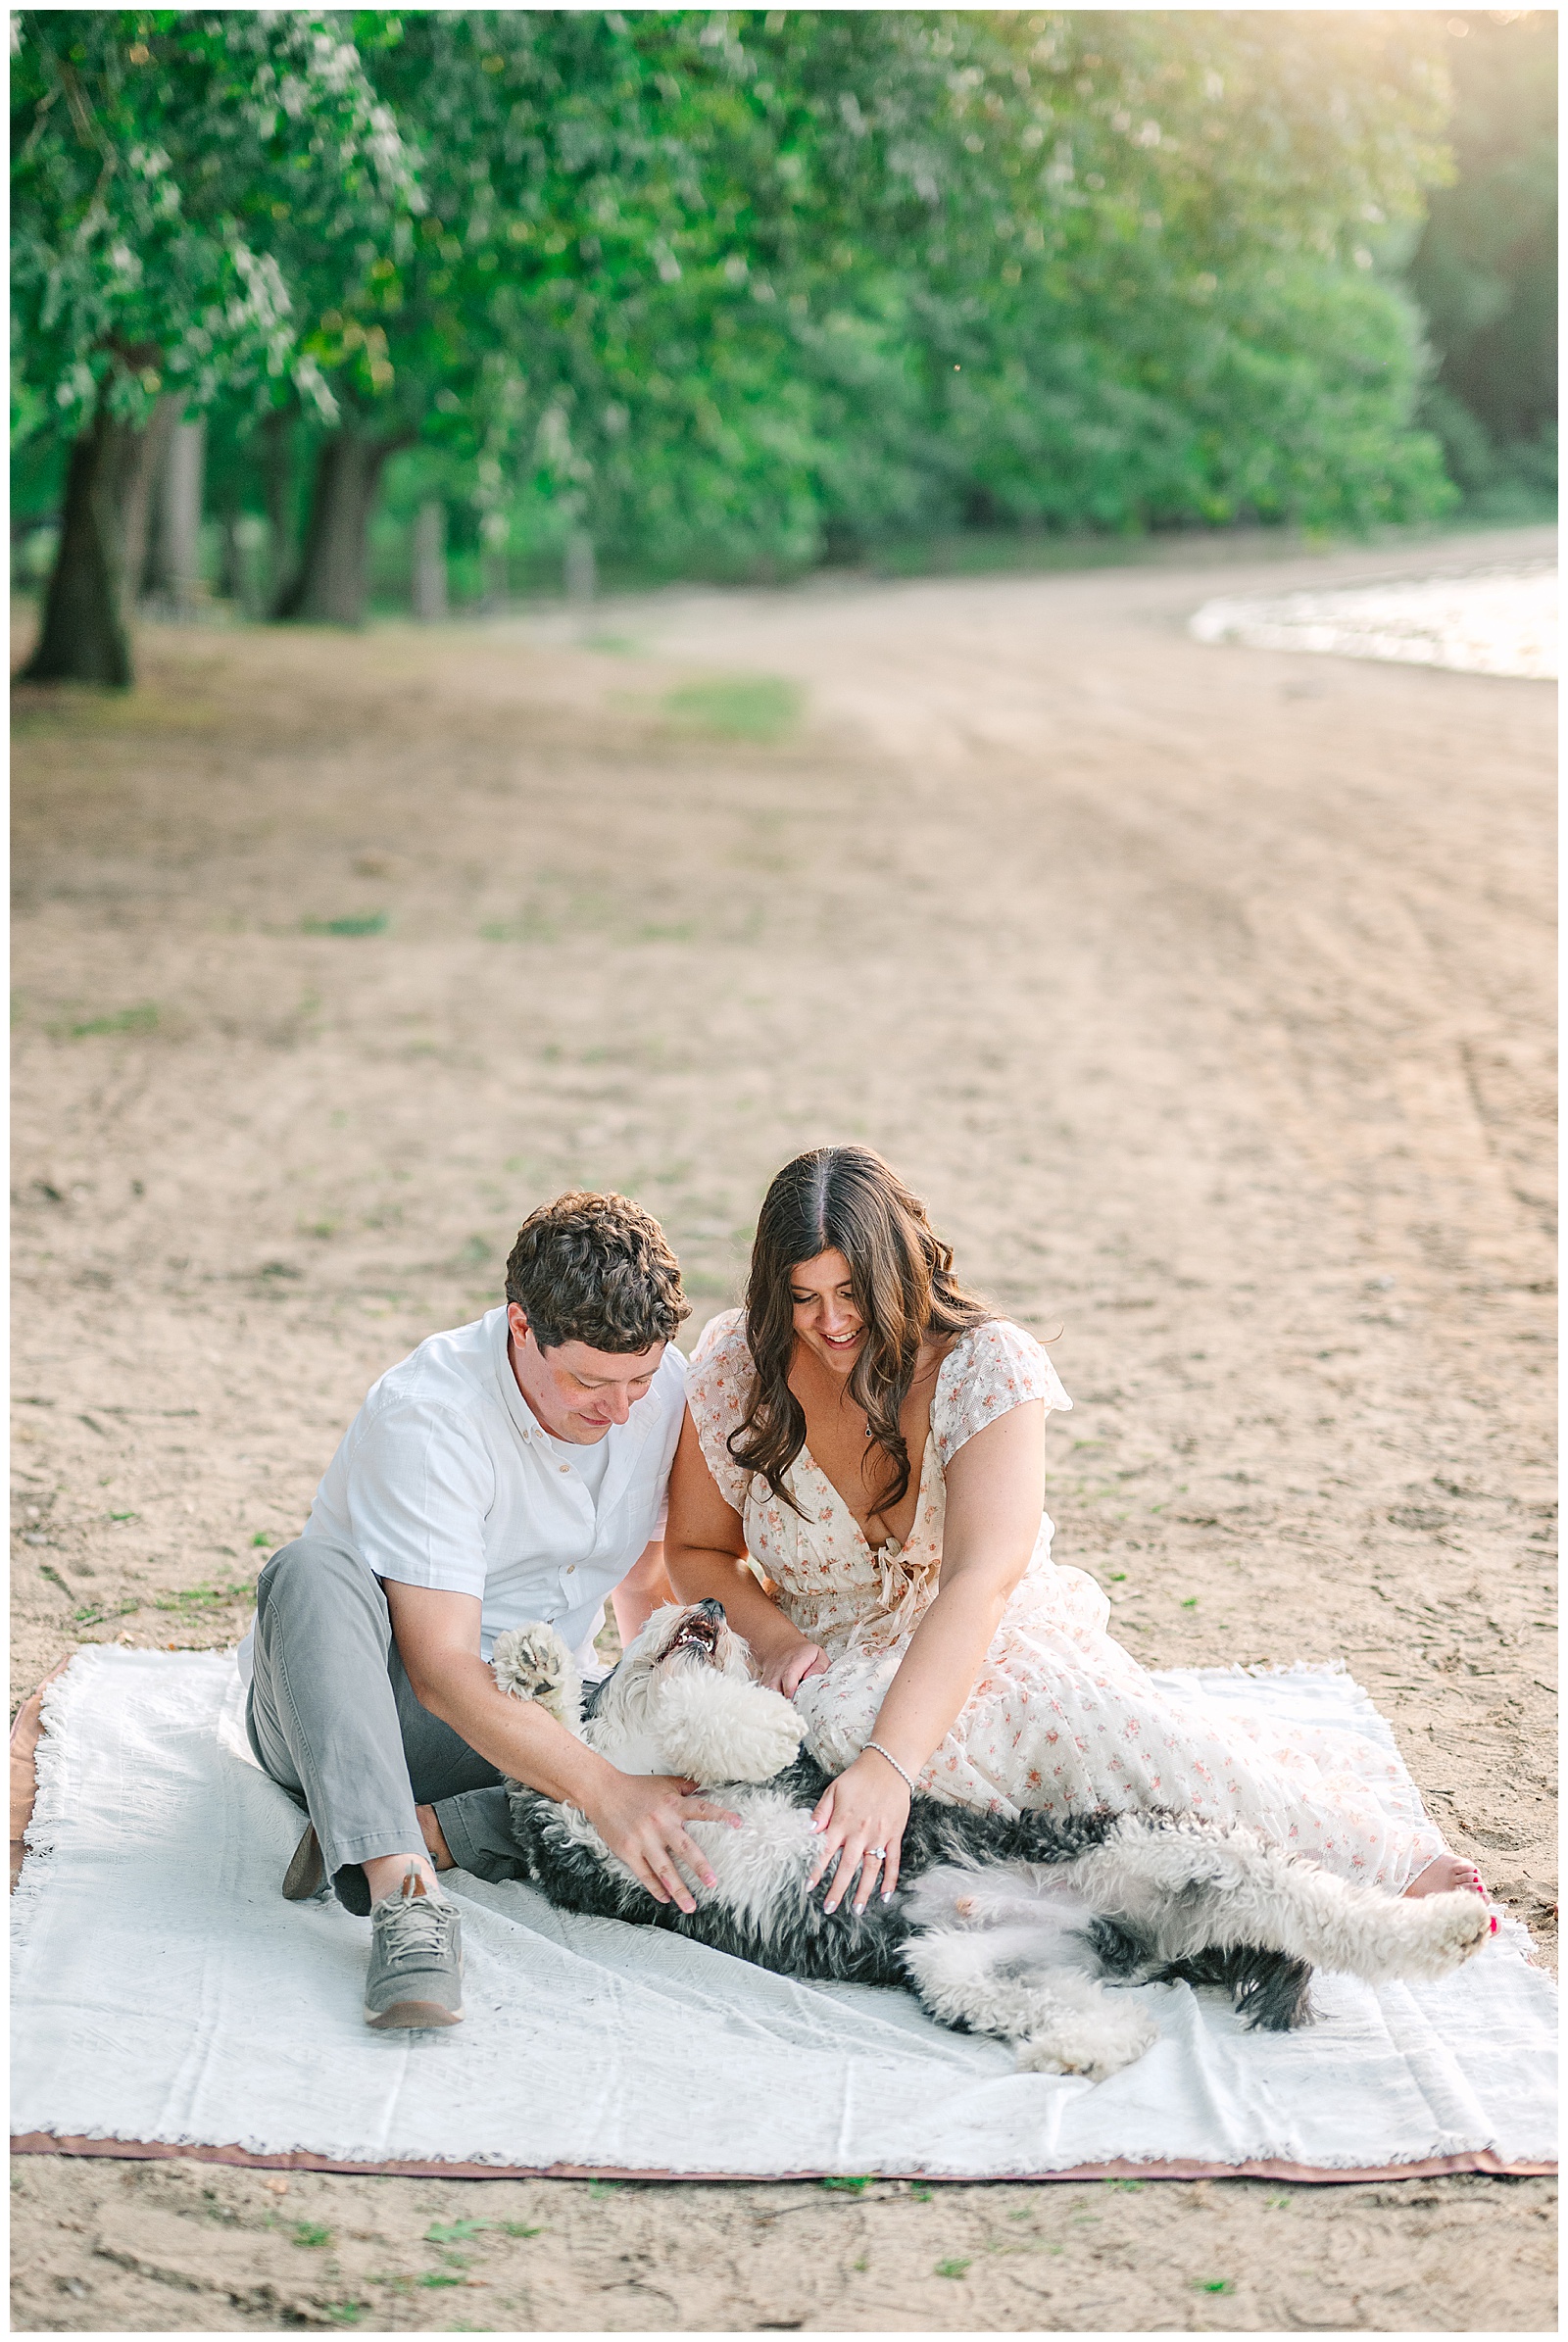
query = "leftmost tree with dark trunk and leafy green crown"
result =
(12, 10, 415, 684)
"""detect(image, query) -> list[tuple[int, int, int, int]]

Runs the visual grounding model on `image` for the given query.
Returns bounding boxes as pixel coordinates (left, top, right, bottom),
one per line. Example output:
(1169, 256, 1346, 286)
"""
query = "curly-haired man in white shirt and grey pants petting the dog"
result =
(239, 1195, 724, 2025)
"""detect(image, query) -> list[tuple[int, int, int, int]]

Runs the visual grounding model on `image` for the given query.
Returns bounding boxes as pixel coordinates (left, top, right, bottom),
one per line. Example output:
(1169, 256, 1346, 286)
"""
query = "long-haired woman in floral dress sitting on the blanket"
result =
(665, 1147, 1482, 1911)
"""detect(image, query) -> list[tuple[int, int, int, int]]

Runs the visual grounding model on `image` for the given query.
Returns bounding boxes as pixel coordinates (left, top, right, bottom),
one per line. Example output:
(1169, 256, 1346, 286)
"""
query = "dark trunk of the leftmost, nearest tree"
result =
(22, 394, 173, 691)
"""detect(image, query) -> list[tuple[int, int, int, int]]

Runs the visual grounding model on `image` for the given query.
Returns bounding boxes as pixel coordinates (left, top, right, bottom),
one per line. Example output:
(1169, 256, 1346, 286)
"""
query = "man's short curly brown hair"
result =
(507, 1188, 692, 1356)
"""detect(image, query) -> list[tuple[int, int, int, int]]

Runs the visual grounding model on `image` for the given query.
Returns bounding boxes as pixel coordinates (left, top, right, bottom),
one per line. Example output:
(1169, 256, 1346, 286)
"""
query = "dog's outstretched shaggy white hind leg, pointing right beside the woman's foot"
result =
(1069, 1815, 1491, 1983)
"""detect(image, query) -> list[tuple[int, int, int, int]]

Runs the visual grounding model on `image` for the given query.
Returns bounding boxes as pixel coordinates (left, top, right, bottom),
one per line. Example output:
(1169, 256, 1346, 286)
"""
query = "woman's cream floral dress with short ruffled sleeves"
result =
(687, 1309, 1442, 1892)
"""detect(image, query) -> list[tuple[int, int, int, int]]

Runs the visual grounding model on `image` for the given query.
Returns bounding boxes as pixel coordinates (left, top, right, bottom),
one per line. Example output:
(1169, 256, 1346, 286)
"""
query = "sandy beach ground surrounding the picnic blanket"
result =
(12, 532, 1556, 2332)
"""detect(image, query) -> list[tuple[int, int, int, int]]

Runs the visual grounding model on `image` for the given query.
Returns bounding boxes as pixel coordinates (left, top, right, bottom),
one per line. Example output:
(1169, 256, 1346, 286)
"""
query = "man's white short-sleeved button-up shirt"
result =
(285, 1307, 687, 1668)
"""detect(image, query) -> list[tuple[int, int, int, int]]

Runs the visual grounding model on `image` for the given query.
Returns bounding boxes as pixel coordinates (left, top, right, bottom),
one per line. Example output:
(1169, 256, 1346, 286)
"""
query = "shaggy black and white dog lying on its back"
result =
(495, 1602, 1491, 2079)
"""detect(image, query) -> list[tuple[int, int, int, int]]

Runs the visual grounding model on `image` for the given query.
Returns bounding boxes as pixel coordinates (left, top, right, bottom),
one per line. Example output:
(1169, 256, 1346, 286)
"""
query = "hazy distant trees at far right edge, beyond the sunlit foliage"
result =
(1411, 10, 1556, 504)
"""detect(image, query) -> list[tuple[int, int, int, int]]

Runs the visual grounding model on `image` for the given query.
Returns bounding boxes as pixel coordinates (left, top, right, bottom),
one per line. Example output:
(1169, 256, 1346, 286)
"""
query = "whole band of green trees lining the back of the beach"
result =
(12, 10, 1556, 681)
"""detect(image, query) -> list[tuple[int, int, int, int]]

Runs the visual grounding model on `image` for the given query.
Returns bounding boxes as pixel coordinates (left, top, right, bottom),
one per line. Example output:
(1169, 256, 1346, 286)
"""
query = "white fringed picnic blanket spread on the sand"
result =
(12, 1646, 1556, 2178)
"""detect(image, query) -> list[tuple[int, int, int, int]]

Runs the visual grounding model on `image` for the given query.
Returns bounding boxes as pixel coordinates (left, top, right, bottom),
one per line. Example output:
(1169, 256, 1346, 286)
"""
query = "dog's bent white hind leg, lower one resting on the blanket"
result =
(903, 1926, 1160, 2082)
